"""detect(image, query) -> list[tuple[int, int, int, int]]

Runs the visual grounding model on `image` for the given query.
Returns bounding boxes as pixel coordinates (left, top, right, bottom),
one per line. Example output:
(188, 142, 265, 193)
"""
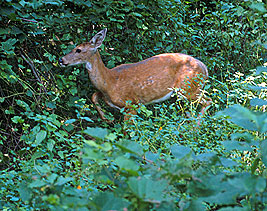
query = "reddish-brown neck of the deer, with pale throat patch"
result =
(86, 51, 115, 94)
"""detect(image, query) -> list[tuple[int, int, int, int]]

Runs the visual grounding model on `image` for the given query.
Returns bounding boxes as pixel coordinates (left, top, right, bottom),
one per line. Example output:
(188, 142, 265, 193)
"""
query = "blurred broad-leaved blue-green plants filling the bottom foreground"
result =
(6, 116, 267, 210)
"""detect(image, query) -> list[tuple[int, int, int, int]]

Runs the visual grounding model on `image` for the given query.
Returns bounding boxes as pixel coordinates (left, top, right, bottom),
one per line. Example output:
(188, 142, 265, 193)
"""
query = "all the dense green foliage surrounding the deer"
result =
(0, 0, 267, 210)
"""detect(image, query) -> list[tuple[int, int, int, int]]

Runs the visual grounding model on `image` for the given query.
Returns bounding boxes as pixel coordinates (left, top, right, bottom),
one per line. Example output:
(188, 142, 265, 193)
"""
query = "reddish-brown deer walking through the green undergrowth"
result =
(59, 29, 211, 123)
